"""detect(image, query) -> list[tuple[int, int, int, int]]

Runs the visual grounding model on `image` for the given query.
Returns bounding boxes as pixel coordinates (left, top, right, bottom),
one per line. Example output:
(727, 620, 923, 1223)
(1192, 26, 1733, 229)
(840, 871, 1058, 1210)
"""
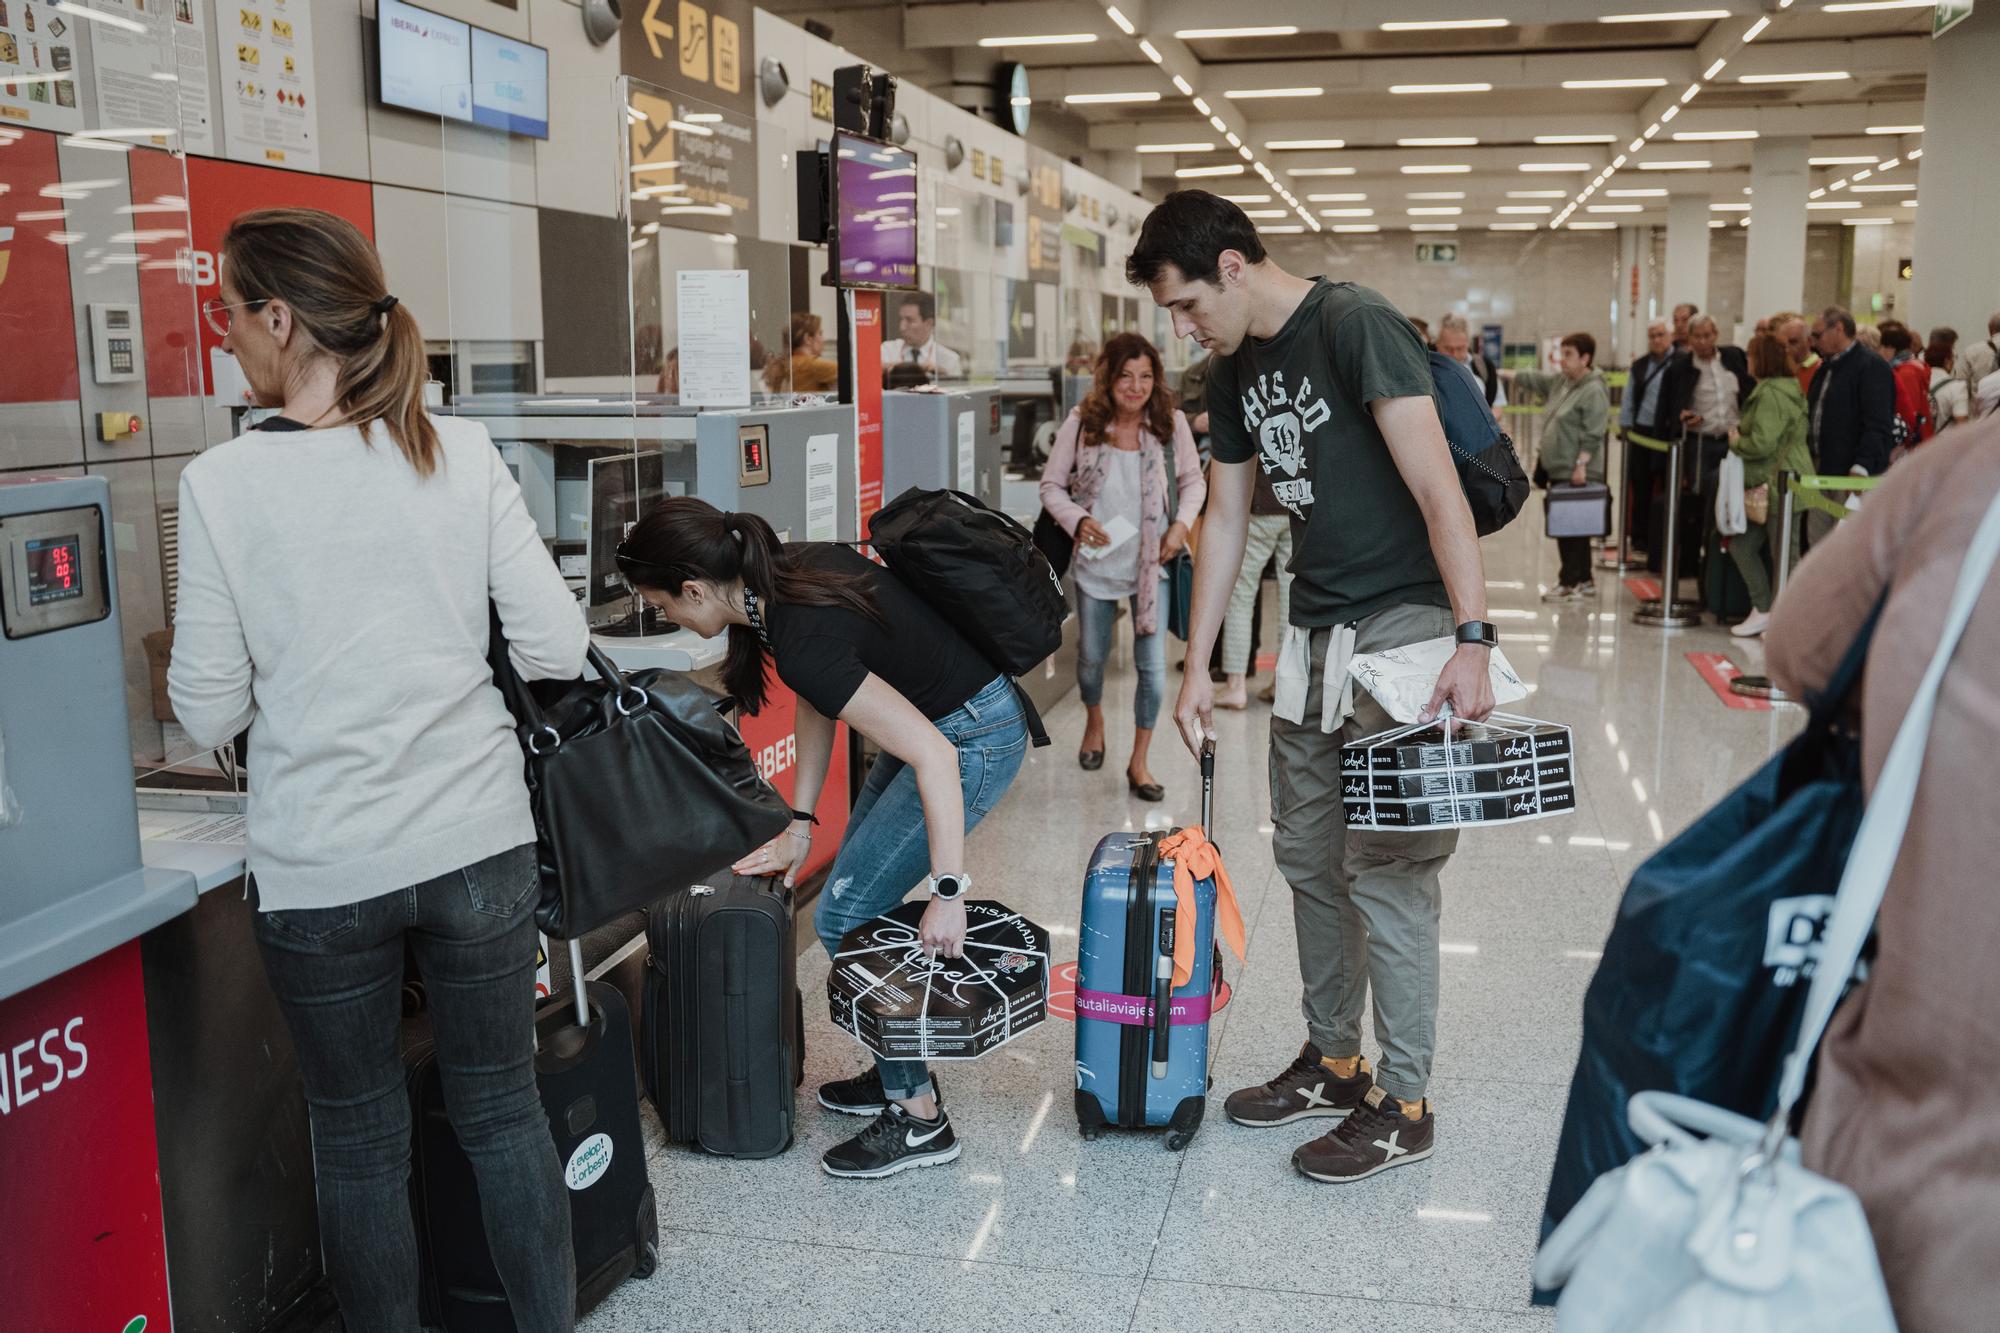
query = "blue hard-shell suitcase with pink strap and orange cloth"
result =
(1076, 743, 1222, 1153)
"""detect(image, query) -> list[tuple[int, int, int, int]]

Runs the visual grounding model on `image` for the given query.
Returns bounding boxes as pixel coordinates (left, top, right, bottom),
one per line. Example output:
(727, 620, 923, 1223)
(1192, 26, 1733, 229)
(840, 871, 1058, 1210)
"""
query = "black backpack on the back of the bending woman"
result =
(868, 486, 1070, 745)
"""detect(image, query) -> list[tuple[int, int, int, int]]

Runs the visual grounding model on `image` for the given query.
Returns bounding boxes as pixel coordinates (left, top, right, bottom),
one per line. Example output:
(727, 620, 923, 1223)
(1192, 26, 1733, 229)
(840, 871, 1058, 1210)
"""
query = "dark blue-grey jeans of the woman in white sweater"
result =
(256, 847, 576, 1333)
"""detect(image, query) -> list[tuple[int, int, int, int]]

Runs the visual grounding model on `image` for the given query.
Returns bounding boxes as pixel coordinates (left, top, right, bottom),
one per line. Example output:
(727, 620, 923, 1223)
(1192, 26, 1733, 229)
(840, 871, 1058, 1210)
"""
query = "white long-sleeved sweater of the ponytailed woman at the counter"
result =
(168, 416, 588, 911)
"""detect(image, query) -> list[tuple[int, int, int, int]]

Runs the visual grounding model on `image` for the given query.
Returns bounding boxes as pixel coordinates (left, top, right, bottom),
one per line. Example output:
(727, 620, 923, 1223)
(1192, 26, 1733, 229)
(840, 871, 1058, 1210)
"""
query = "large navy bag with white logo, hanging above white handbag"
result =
(1536, 606, 1880, 1303)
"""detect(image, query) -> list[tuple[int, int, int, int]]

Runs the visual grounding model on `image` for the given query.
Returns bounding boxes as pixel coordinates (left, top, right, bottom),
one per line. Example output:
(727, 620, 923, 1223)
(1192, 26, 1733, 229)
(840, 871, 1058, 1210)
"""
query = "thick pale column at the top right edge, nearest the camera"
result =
(1910, 0, 2000, 344)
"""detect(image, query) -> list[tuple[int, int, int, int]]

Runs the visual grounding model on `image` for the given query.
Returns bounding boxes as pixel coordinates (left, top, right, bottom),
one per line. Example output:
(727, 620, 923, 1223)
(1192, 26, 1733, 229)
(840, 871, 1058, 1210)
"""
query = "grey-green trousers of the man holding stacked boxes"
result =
(1270, 606, 1458, 1101)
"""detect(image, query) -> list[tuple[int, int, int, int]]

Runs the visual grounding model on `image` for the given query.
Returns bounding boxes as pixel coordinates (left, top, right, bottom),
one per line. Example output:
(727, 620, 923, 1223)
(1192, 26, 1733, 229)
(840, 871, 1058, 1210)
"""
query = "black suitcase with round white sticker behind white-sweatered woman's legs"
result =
(406, 941, 660, 1333)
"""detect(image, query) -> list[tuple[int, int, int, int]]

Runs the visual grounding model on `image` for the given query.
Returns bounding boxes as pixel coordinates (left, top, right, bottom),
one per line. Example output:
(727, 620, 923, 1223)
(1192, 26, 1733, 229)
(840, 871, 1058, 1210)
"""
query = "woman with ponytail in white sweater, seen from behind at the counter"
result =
(168, 208, 588, 1333)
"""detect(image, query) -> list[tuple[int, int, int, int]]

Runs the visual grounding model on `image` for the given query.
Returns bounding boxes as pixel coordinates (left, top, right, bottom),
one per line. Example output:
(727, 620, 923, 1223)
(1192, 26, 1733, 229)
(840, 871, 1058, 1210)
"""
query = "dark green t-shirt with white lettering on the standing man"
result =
(1208, 278, 1452, 628)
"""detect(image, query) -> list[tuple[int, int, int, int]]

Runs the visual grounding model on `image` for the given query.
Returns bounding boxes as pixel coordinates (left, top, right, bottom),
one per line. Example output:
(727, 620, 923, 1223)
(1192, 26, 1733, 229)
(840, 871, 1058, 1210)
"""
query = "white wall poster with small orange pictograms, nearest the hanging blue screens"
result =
(216, 0, 320, 172)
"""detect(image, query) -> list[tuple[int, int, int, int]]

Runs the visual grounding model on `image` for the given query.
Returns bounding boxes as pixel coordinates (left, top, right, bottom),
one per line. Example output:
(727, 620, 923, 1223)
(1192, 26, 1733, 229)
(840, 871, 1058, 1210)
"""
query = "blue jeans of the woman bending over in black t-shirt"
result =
(812, 677, 1028, 1101)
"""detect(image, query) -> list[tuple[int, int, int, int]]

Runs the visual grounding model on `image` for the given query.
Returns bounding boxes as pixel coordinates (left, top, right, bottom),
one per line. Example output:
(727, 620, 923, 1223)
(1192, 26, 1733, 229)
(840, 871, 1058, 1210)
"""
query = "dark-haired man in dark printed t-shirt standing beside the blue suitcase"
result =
(1126, 190, 1492, 1181)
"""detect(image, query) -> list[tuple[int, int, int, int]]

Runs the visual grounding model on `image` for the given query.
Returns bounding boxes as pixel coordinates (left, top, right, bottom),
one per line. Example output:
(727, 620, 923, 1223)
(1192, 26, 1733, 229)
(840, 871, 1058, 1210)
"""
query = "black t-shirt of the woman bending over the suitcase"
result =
(764, 542, 1000, 721)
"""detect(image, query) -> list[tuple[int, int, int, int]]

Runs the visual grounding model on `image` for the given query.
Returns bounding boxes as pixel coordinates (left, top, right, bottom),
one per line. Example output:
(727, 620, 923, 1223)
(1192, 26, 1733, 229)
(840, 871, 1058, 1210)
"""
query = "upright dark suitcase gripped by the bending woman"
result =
(640, 877, 806, 1157)
